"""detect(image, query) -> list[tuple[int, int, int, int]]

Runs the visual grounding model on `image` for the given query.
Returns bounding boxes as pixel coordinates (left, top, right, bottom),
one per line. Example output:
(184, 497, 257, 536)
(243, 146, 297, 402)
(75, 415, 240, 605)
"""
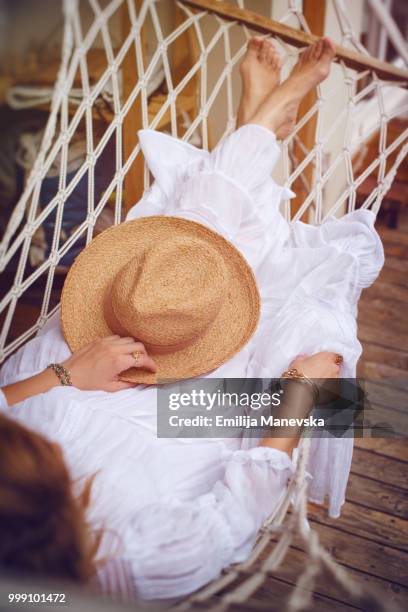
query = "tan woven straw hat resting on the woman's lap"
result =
(61, 216, 259, 384)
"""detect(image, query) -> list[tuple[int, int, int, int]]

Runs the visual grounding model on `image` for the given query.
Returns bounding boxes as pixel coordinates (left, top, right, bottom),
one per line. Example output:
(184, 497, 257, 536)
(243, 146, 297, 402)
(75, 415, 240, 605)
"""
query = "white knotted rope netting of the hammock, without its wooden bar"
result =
(0, 0, 408, 611)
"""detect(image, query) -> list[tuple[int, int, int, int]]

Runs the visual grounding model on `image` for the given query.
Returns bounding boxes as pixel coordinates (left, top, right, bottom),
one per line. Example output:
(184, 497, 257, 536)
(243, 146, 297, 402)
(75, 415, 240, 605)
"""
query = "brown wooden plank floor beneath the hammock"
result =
(230, 211, 408, 612)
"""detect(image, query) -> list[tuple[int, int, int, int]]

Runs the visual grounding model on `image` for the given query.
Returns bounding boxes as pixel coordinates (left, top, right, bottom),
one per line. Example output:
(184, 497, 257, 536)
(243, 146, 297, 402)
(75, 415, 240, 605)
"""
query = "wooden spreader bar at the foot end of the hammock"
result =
(181, 0, 408, 87)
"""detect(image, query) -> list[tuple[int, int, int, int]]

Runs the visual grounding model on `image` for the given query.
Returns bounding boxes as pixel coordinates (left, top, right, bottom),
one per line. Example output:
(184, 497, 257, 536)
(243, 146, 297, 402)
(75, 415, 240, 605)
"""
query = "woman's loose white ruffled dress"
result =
(0, 125, 383, 598)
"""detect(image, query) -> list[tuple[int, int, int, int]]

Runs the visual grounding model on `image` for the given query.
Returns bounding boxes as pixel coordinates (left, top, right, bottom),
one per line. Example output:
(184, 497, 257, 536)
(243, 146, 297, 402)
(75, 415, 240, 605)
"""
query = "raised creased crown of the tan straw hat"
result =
(111, 237, 228, 352)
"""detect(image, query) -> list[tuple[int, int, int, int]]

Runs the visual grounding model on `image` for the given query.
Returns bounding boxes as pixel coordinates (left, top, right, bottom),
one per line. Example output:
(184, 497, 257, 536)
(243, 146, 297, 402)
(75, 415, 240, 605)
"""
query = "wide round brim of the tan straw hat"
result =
(61, 216, 260, 384)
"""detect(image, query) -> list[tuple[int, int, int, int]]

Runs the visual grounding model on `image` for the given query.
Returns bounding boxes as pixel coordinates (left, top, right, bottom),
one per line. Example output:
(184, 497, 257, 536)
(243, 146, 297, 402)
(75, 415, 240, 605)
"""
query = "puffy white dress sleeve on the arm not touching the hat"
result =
(124, 447, 293, 599)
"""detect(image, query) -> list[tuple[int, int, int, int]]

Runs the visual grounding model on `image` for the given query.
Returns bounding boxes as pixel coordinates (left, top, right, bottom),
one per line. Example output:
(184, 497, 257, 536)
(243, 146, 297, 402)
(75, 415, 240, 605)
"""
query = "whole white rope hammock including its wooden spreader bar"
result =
(0, 0, 408, 610)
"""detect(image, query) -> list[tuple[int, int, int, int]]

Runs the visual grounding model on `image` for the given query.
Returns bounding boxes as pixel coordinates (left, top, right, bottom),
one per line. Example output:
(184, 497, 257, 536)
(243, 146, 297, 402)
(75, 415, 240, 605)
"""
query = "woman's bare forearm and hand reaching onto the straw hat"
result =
(2, 336, 156, 406)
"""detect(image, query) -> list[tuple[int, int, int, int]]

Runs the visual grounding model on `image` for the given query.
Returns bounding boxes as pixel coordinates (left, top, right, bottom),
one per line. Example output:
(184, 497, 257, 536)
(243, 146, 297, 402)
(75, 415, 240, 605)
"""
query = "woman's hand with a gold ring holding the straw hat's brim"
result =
(63, 336, 157, 391)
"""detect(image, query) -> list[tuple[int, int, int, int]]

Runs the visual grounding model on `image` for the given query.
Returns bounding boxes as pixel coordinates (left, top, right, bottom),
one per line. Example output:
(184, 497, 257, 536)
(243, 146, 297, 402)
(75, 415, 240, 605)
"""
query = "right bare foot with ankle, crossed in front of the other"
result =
(250, 38, 335, 138)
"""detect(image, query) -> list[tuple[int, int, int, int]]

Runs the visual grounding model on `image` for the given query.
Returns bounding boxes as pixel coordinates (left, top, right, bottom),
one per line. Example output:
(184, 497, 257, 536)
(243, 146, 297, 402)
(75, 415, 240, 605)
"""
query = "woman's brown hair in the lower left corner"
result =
(0, 415, 101, 581)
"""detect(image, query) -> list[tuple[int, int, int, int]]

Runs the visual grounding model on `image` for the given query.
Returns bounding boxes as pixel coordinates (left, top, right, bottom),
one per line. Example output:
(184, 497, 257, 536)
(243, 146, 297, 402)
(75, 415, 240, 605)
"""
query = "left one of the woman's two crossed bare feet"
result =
(237, 37, 281, 127)
